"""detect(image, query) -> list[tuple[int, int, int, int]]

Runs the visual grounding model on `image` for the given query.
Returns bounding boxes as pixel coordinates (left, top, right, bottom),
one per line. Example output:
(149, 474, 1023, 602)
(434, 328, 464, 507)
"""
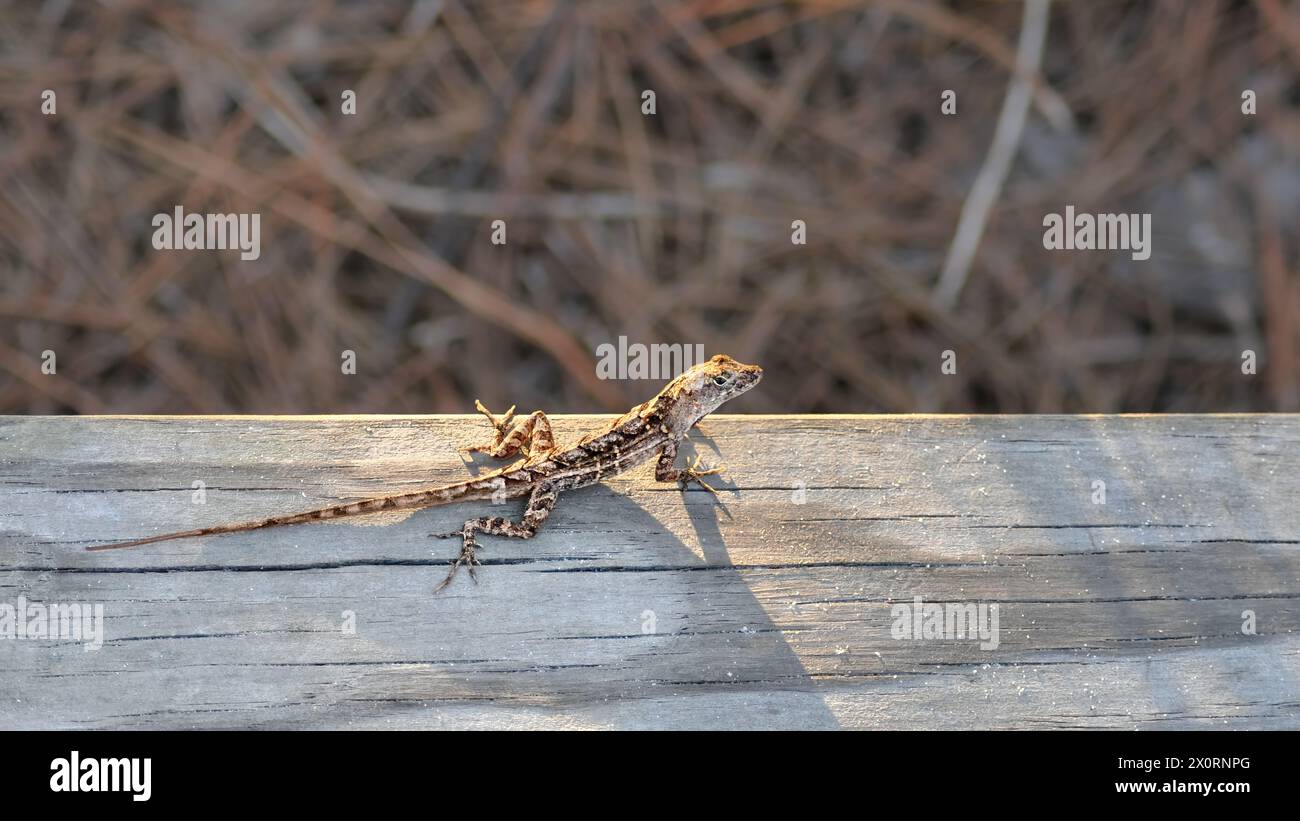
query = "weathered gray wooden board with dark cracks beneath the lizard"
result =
(0, 416, 1300, 727)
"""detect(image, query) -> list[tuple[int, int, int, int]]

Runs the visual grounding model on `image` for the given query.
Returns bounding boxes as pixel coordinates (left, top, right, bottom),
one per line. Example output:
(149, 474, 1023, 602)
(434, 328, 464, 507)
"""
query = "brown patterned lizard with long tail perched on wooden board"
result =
(86, 355, 763, 592)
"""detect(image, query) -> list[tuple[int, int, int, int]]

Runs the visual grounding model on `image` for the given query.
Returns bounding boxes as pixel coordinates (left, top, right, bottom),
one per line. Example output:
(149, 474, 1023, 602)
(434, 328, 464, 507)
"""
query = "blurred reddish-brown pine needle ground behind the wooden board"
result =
(0, 0, 1300, 413)
